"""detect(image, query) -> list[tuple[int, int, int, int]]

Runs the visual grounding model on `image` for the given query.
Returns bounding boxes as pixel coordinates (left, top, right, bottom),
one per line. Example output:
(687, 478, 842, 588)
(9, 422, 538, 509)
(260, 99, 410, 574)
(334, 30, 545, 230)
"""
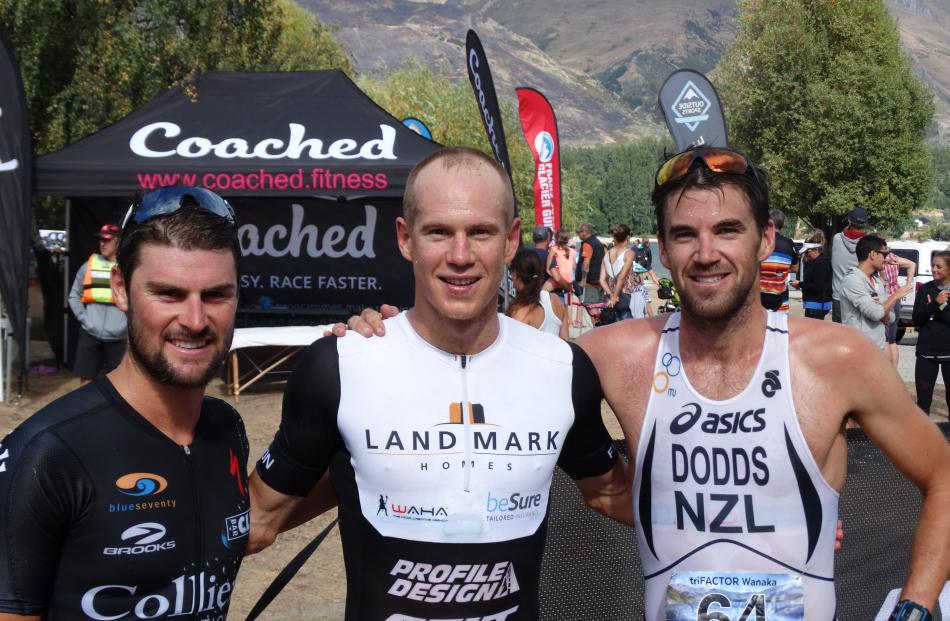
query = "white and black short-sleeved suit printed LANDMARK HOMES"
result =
(257, 314, 615, 621)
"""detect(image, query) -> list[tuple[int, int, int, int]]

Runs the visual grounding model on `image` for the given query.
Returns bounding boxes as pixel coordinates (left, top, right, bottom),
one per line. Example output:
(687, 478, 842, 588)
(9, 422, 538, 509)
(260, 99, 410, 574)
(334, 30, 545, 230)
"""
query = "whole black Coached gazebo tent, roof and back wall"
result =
(35, 70, 438, 364)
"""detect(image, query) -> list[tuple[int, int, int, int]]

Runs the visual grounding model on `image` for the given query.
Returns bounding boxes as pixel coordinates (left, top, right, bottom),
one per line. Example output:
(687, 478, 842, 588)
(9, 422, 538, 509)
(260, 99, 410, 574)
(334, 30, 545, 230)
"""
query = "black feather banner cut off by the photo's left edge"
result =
(0, 33, 32, 380)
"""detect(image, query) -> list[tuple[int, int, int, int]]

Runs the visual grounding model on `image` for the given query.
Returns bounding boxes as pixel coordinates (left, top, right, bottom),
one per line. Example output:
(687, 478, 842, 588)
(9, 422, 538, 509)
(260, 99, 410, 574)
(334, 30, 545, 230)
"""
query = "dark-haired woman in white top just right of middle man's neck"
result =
(505, 248, 569, 339)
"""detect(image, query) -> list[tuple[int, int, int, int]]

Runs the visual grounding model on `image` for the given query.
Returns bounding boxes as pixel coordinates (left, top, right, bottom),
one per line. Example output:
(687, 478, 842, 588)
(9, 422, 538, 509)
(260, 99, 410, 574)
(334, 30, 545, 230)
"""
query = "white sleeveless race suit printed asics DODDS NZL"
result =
(633, 312, 838, 621)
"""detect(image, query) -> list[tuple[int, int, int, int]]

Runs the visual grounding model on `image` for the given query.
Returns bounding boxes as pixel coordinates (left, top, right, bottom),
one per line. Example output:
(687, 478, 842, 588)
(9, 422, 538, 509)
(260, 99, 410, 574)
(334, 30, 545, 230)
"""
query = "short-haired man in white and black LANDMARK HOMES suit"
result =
(249, 148, 632, 621)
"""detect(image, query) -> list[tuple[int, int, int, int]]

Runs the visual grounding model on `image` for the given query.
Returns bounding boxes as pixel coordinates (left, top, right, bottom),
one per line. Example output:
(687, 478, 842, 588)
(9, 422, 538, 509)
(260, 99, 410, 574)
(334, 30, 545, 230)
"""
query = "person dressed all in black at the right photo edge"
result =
(914, 250, 950, 414)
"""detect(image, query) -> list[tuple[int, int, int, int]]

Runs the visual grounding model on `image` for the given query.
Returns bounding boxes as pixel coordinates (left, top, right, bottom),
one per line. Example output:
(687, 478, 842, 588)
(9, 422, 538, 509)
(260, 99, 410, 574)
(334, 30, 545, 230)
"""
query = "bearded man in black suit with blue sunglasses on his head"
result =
(0, 188, 249, 621)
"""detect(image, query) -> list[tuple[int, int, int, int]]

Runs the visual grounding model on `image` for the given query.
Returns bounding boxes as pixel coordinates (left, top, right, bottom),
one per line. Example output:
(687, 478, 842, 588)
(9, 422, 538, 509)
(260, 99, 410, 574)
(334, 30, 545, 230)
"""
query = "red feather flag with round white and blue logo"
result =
(515, 87, 561, 231)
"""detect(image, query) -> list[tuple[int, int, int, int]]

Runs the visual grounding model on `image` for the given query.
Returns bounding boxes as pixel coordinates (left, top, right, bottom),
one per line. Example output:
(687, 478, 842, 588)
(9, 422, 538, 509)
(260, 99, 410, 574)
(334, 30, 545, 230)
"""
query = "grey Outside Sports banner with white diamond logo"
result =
(660, 69, 729, 151)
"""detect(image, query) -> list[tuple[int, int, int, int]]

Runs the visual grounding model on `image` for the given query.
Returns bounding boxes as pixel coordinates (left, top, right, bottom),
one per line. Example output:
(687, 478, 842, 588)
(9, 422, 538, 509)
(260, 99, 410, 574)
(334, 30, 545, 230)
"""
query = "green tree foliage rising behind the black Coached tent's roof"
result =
(0, 0, 351, 154)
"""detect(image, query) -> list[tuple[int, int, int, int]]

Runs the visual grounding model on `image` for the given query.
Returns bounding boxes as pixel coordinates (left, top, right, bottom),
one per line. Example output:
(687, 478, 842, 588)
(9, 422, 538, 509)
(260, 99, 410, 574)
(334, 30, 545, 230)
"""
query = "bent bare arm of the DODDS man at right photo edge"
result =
(839, 342, 950, 610)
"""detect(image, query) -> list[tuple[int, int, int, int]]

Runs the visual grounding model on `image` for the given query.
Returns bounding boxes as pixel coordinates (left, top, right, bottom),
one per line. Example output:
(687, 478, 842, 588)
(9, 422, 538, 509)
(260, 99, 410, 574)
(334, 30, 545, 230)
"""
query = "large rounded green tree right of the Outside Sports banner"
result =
(716, 0, 933, 240)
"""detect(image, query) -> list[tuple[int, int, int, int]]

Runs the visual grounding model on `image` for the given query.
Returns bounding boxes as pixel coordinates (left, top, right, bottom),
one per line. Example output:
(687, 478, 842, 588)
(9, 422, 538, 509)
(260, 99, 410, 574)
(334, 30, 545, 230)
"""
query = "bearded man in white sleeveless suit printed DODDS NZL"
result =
(578, 148, 950, 621)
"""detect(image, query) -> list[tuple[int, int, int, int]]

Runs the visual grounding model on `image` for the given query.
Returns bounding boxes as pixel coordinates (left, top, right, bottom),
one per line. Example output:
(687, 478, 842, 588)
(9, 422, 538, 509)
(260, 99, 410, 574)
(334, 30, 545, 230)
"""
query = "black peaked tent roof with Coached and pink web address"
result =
(35, 70, 438, 198)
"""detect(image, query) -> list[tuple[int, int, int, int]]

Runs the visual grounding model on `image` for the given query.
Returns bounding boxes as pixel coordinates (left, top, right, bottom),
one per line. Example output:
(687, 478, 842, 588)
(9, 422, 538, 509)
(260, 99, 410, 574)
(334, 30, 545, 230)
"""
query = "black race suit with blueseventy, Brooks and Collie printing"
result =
(0, 378, 249, 621)
